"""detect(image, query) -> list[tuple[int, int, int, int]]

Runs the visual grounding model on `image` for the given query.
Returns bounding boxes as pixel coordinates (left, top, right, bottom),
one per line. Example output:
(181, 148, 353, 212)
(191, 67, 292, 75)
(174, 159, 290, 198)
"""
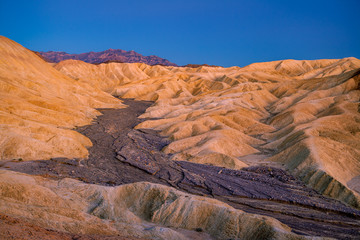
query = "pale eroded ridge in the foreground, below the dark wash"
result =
(0, 170, 321, 240)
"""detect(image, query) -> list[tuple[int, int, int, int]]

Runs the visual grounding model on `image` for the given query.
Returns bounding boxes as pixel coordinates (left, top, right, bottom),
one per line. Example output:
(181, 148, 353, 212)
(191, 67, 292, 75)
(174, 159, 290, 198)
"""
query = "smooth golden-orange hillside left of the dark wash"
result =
(0, 37, 122, 160)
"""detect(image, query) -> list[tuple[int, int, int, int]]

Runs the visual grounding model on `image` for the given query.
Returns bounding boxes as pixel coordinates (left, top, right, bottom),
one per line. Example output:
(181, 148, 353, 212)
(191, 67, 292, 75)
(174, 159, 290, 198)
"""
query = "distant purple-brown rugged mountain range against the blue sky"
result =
(38, 49, 177, 66)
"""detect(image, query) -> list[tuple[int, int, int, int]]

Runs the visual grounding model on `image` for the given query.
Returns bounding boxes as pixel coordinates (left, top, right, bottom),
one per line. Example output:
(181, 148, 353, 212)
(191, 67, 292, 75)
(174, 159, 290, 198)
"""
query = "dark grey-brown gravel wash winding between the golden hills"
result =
(3, 99, 360, 239)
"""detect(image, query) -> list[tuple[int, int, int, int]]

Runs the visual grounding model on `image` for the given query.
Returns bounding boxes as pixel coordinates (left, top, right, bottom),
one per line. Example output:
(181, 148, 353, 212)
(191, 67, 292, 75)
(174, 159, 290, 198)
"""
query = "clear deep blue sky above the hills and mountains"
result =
(0, 0, 360, 67)
